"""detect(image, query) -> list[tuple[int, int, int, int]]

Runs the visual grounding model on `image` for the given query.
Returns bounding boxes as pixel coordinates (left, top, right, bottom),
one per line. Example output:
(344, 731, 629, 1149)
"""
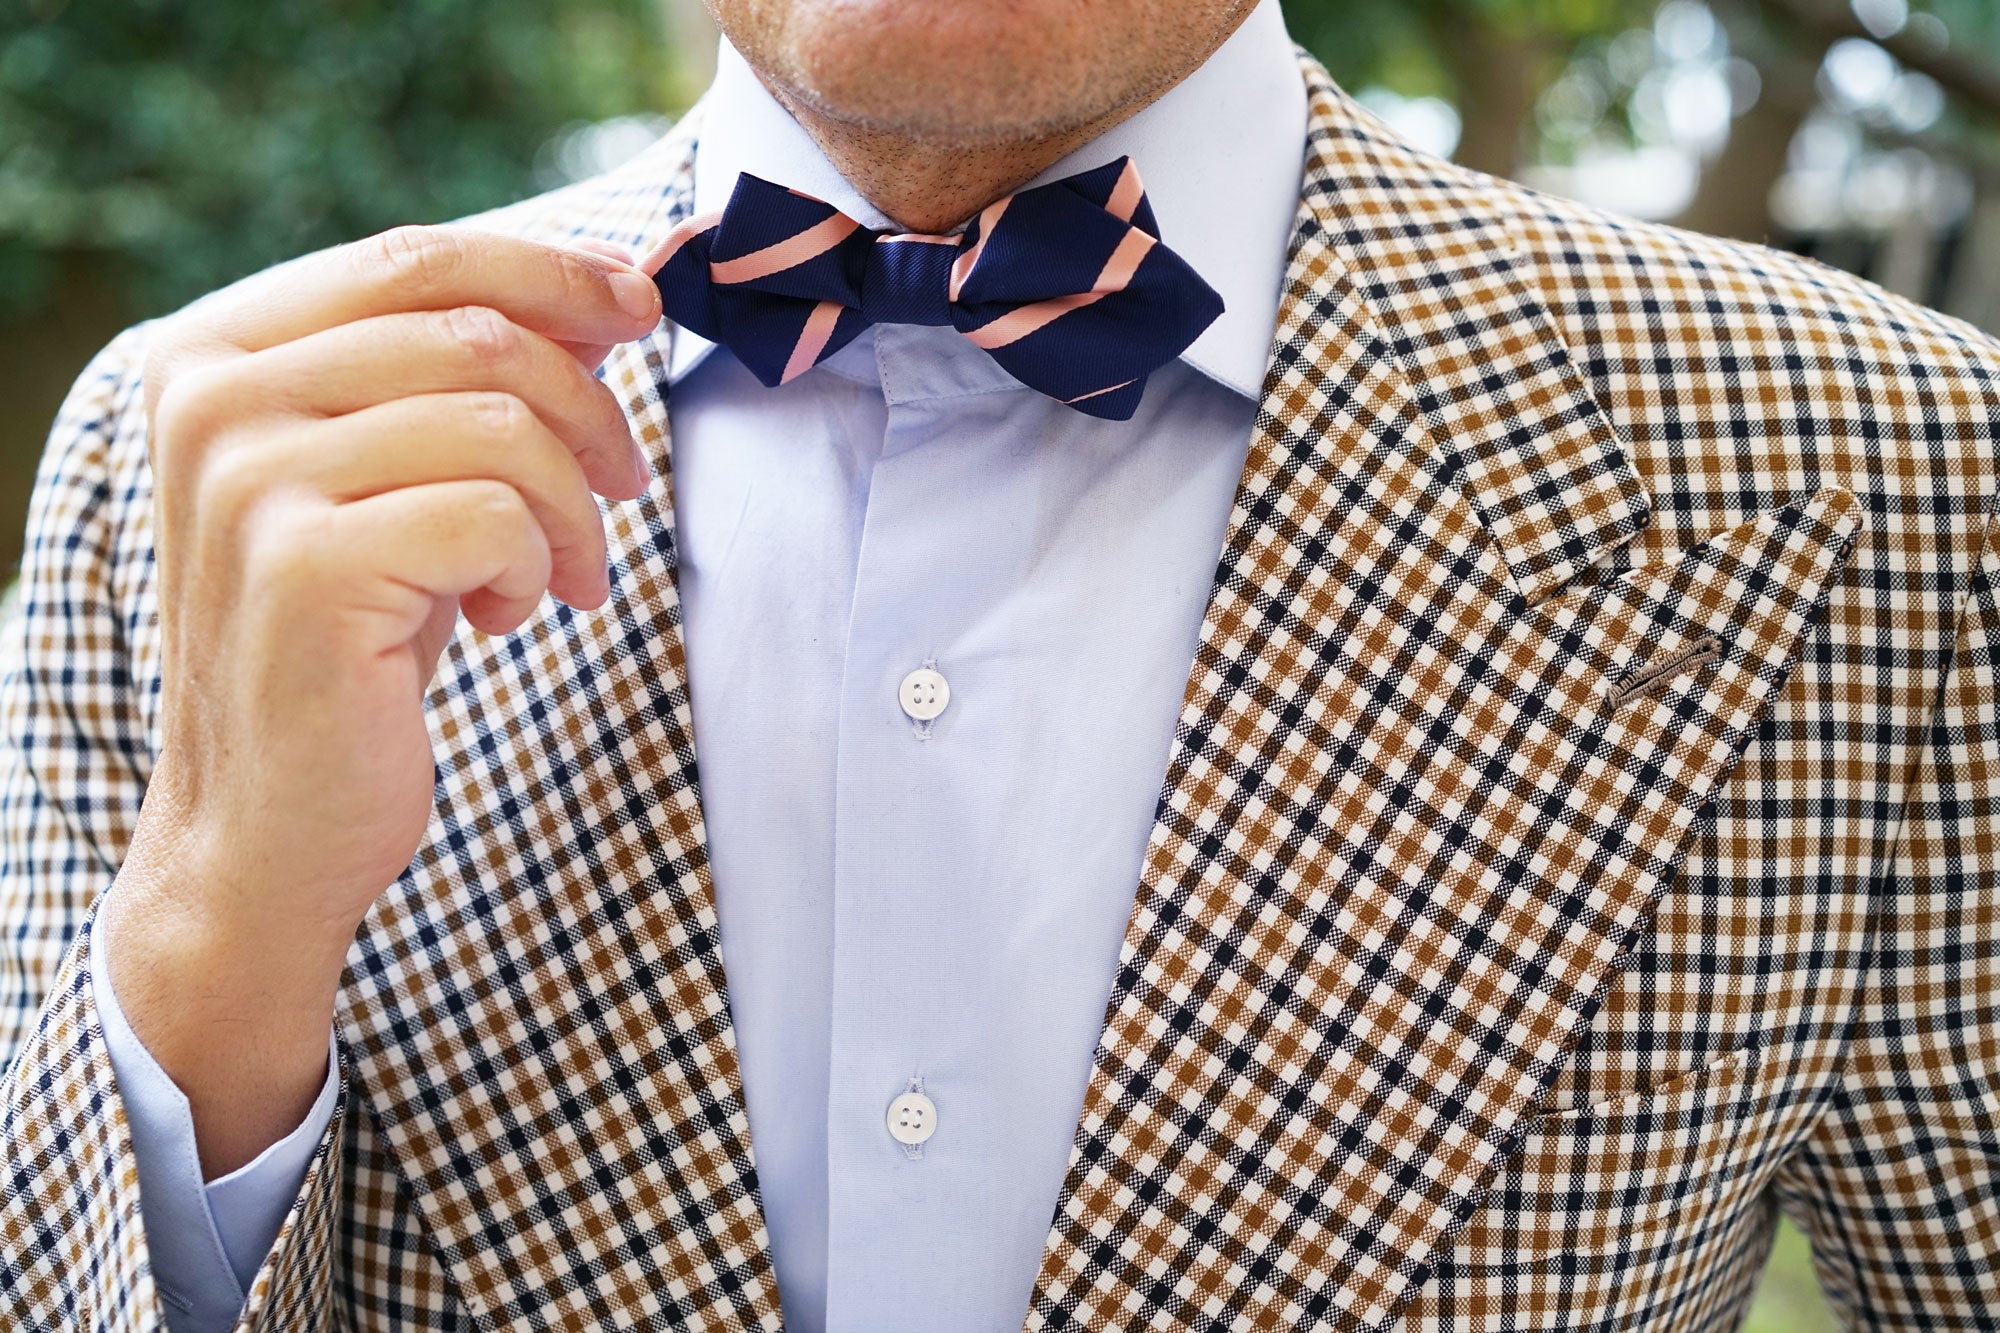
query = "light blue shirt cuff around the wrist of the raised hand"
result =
(90, 908, 340, 1333)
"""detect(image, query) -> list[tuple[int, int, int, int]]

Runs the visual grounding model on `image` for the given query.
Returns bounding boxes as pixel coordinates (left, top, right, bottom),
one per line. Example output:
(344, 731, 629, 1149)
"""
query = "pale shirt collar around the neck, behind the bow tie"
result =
(668, 0, 1306, 398)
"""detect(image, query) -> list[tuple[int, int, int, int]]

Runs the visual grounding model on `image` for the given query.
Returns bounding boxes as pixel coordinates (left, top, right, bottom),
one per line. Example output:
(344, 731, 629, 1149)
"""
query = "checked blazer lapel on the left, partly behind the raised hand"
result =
(328, 109, 778, 1329)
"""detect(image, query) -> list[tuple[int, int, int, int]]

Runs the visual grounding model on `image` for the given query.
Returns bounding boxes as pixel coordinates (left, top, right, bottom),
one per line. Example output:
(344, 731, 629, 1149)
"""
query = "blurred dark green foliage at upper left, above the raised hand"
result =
(0, 0, 678, 314)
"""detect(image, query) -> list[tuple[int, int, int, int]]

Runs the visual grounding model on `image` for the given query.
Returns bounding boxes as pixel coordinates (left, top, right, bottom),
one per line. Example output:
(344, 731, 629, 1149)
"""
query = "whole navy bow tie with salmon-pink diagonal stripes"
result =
(654, 158, 1222, 420)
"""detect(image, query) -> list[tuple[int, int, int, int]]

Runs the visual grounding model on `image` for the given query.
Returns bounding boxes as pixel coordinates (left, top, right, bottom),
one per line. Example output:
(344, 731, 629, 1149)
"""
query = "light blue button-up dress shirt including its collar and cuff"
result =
(94, 0, 1306, 1333)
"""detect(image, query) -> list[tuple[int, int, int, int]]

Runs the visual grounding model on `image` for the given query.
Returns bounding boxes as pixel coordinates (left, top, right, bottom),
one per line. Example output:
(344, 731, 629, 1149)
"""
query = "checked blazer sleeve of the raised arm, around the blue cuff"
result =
(0, 326, 346, 1333)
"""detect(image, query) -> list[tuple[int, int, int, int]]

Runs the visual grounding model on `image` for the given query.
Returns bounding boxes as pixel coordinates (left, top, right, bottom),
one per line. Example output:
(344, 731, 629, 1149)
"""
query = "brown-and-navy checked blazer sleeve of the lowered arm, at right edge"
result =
(1780, 498, 2000, 1333)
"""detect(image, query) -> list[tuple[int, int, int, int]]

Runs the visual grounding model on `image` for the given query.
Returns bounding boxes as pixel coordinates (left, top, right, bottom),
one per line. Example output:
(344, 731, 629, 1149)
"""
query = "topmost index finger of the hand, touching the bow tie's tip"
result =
(184, 226, 660, 352)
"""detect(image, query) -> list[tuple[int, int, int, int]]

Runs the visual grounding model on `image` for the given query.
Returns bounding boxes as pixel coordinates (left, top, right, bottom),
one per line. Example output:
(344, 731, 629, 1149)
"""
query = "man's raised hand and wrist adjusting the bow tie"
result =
(104, 228, 660, 1177)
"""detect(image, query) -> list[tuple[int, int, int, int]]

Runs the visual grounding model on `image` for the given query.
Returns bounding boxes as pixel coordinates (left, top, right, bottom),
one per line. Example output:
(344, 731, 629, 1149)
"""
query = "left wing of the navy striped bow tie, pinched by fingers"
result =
(654, 174, 874, 386)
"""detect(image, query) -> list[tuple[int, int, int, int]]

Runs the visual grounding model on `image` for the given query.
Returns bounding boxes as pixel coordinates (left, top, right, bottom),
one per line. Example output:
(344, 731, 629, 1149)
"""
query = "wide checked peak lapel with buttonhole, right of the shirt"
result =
(1028, 60, 1858, 1329)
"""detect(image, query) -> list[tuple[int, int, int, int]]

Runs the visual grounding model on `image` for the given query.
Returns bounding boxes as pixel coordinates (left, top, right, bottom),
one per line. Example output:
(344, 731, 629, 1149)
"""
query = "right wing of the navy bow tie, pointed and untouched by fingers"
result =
(952, 160, 1222, 420)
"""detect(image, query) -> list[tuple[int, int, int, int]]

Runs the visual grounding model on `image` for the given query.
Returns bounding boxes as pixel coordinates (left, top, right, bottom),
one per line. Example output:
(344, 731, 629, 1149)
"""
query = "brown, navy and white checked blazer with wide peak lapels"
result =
(0, 60, 2000, 1331)
